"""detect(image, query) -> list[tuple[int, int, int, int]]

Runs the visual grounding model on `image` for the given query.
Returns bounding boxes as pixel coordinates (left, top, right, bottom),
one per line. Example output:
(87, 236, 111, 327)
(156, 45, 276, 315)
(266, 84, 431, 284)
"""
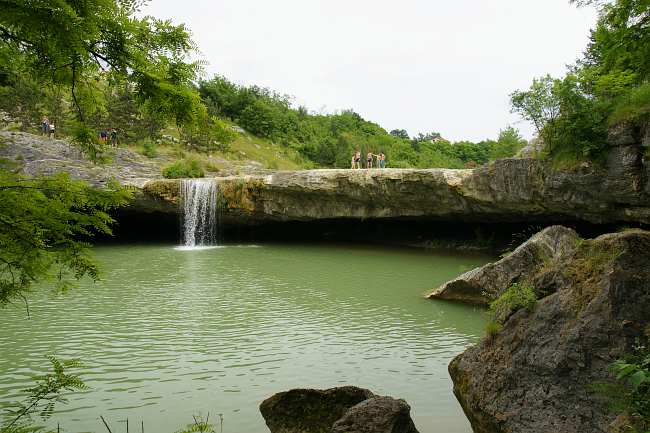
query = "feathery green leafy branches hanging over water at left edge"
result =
(0, 170, 130, 313)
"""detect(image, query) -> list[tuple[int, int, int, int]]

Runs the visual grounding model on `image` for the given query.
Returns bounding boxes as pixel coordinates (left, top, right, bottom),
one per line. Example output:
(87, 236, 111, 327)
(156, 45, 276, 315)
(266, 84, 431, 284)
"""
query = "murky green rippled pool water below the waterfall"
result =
(0, 245, 487, 433)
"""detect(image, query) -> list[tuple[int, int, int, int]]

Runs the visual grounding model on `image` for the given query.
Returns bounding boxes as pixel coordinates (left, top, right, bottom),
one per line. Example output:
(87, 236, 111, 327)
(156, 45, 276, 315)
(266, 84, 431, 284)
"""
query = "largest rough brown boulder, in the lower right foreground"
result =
(449, 231, 650, 433)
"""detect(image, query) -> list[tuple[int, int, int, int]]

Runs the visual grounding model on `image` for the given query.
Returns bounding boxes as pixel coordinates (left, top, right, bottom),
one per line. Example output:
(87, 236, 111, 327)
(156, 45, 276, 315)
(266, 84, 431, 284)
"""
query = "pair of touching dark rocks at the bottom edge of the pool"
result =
(260, 386, 417, 433)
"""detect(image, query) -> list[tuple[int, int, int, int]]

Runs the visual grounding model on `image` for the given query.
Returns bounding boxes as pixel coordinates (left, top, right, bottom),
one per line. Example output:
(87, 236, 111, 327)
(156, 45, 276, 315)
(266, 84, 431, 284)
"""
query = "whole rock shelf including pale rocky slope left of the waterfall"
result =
(5, 123, 650, 225)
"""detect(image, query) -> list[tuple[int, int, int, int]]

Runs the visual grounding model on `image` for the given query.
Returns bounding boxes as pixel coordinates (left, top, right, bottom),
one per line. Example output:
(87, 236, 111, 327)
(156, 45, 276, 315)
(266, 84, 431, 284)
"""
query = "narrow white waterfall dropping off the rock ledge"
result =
(180, 179, 220, 248)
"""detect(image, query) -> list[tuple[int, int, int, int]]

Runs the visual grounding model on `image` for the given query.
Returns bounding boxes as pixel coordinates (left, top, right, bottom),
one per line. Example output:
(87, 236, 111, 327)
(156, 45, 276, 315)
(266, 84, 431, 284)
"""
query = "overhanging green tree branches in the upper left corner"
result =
(0, 0, 201, 132)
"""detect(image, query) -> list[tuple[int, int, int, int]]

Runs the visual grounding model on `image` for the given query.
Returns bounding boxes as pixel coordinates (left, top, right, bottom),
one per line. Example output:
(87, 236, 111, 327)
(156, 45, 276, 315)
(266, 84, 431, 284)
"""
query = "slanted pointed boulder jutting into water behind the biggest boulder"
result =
(428, 226, 579, 304)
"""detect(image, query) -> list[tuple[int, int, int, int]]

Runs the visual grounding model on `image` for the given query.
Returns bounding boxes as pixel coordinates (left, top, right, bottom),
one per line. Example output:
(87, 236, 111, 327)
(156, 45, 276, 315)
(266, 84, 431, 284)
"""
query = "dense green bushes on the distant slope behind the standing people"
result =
(199, 76, 526, 168)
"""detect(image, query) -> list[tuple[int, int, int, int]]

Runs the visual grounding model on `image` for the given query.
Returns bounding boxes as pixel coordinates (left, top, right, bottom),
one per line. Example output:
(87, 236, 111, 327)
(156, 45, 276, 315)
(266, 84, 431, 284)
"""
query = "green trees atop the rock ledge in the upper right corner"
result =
(511, 0, 650, 160)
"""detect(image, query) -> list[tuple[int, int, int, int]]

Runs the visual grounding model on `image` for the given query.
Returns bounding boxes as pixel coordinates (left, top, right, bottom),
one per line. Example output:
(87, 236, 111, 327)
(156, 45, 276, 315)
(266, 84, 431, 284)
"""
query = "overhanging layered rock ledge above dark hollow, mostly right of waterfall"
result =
(142, 148, 650, 225)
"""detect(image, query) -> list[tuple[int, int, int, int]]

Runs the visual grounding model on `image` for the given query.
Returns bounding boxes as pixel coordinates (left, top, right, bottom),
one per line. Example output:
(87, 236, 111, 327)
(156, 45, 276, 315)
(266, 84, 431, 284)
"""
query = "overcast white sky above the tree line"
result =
(143, 0, 596, 141)
